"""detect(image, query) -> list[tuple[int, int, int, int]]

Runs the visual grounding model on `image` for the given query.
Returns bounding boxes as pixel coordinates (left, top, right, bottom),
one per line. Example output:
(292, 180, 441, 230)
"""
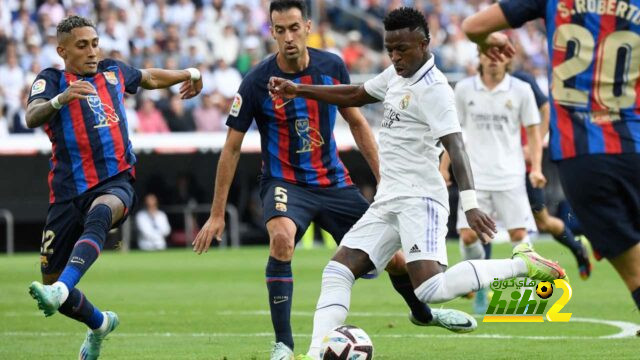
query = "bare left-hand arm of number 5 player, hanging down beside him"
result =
(192, 128, 244, 255)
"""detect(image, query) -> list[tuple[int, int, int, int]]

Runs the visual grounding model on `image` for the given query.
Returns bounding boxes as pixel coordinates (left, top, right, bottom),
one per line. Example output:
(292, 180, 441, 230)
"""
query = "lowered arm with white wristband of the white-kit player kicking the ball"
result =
(440, 132, 496, 242)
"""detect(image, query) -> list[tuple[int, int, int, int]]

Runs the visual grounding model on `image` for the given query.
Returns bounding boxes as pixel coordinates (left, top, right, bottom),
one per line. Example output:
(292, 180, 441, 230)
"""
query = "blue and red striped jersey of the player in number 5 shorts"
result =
(227, 48, 353, 187)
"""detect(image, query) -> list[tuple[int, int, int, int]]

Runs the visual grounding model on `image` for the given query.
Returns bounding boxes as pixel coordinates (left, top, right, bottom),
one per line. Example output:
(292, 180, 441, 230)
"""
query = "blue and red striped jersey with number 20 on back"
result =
(500, 0, 640, 160)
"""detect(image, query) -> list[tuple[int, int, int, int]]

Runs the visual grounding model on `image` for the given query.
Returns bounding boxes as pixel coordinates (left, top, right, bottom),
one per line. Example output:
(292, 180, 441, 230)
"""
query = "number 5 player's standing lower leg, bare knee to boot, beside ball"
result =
(265, 216, 297, 360)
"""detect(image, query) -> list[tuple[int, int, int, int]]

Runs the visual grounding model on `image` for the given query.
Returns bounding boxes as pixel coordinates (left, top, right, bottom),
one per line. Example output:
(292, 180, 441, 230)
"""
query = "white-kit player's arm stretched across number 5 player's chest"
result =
(269, 77, 380, 107)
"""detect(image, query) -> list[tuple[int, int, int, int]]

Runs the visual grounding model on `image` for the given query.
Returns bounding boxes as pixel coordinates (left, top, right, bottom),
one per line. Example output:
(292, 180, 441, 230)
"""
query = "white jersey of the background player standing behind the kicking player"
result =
(455, 74, 540, 191)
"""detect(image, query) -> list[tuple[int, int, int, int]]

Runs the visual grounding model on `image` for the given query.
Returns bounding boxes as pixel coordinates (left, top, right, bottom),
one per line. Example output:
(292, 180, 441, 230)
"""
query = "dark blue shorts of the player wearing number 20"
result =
(558, 154, 640, 259)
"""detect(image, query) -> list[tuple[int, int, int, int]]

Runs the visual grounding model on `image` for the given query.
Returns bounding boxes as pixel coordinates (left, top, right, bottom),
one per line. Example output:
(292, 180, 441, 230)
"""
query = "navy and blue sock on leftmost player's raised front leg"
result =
(58, 204, 111, 291)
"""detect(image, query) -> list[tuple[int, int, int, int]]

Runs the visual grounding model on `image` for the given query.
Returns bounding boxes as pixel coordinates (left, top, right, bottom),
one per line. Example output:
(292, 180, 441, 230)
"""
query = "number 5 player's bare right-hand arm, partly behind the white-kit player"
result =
(340, 107, 380, 182)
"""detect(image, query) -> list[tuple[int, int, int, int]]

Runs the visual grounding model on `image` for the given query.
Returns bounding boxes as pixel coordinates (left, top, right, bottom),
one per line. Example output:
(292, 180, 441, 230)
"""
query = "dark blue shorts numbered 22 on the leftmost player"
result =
(40, 172, 137, 274)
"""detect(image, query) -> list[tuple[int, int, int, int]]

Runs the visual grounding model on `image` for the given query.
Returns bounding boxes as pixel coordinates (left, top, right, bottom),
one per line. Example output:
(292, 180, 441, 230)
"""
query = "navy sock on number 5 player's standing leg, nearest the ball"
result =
(266, 256, 293, 350)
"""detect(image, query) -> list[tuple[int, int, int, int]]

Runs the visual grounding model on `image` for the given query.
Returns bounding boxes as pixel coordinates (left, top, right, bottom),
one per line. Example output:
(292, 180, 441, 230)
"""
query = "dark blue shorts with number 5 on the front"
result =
(260, 179, 369, 243)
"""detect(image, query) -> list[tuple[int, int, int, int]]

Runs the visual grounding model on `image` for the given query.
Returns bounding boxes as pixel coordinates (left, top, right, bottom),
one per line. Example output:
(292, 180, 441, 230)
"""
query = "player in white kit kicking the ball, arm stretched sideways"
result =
(269, 8, 565, 359)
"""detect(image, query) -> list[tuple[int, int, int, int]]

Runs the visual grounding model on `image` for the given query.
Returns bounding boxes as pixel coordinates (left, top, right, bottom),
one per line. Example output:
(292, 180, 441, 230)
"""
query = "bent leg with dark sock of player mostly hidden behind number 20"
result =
(533, 207, 592, 279)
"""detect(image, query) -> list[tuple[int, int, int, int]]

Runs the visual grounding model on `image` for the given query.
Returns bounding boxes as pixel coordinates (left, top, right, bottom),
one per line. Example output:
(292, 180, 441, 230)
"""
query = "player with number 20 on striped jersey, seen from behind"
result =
(463, 0, 640, 320)
